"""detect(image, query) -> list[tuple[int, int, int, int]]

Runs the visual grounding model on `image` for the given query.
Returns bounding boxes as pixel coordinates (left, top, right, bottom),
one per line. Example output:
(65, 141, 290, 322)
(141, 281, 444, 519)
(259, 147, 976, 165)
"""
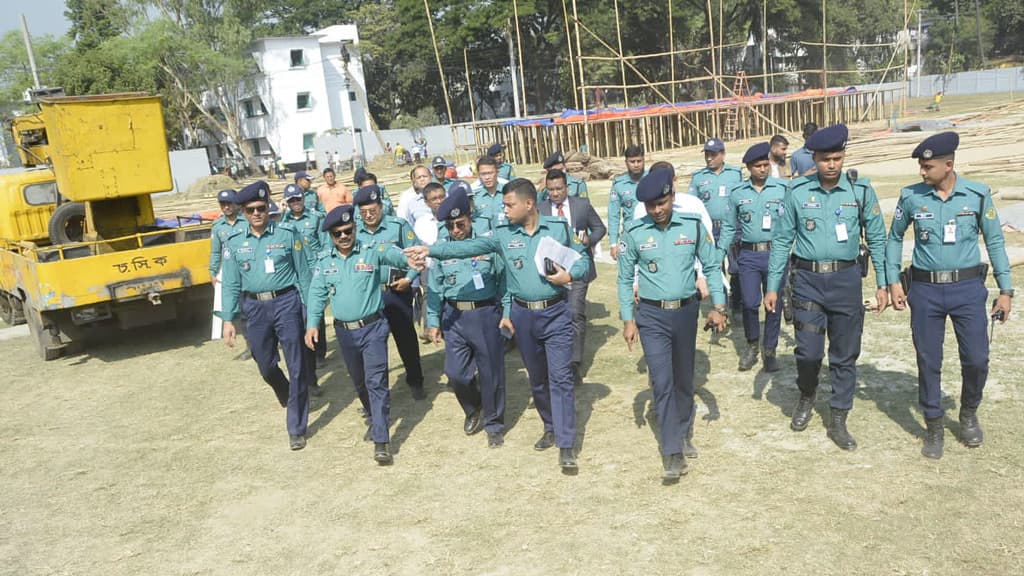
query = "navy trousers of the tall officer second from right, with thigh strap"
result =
(793, 265, 864, 410)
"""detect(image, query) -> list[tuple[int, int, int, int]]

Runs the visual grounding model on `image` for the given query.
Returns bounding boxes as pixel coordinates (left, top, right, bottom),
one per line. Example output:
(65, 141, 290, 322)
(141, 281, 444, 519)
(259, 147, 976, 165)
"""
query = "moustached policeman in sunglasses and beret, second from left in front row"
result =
(305, 204, 406, 465)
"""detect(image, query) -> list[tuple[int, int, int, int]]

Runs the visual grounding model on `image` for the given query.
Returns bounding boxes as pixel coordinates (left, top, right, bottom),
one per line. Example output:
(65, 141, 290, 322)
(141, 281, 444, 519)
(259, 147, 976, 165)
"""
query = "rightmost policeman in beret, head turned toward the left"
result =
(886, 132, 1014, 459)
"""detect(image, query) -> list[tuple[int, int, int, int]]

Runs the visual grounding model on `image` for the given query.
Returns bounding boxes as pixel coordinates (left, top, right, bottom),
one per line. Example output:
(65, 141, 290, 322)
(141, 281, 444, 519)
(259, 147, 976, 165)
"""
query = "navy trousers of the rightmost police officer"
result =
(907, 278, 988, 418)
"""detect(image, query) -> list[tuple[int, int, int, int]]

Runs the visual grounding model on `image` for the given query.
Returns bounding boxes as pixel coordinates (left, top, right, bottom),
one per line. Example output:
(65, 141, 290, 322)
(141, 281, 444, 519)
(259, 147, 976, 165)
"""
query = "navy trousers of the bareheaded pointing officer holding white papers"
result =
(510, 300, 575, 448)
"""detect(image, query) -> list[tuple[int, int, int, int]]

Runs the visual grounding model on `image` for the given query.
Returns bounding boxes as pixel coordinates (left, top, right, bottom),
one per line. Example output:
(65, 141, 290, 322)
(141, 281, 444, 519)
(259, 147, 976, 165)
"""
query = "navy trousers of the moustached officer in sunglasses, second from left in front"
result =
(334, 318, 391, 442)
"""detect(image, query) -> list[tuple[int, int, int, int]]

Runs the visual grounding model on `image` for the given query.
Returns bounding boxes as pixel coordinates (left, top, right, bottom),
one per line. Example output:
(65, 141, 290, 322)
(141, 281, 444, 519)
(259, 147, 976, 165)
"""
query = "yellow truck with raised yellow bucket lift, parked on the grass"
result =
(0, 93, 213, 360)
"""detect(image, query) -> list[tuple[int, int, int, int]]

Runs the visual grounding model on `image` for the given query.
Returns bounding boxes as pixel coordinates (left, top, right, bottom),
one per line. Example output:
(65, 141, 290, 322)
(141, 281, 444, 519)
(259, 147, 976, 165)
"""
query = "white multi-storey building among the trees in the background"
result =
(205, 25, 373, 170)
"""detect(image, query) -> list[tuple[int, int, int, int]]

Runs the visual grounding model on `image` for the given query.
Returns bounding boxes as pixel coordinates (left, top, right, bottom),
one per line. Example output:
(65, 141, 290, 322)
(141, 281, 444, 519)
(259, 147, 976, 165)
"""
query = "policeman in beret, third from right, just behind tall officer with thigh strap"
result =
(718, 142, 786, 372)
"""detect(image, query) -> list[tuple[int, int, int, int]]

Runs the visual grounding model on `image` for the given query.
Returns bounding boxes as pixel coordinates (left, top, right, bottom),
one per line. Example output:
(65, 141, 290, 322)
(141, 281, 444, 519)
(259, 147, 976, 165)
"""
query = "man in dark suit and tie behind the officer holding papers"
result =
(538, 169, 608, 383)
